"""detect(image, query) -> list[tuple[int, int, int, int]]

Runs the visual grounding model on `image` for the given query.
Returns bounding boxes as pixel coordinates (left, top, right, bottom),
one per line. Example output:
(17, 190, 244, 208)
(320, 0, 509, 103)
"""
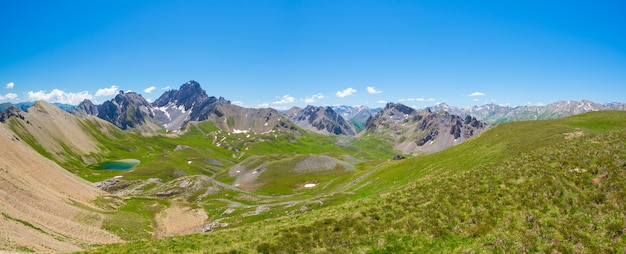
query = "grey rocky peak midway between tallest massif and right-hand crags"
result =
(285, 106, 356, 136)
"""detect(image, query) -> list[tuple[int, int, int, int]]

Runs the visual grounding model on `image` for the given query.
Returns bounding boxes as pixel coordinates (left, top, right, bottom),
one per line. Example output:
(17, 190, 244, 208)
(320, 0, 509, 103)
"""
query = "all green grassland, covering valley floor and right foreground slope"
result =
(12, 111, 626, 253)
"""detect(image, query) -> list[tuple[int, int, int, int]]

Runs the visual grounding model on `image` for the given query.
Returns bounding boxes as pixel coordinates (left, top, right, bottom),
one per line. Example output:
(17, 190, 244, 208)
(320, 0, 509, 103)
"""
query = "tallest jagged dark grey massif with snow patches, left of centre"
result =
(72, 81, 297, 133)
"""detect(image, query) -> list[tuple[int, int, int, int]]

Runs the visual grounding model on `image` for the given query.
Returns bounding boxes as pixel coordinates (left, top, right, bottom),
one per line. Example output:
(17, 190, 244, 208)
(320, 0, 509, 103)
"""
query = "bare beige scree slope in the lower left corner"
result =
(0, 124, 121, 253)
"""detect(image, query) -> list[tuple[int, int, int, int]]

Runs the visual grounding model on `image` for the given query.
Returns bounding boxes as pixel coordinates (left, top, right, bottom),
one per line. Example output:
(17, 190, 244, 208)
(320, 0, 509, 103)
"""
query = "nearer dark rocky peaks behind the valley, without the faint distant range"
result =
(69, 81, 486, 153)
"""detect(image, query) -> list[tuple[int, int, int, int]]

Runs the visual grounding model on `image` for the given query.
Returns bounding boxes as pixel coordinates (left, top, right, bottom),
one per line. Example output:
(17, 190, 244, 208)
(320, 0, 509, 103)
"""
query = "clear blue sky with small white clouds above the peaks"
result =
(0, 0, 626, 109)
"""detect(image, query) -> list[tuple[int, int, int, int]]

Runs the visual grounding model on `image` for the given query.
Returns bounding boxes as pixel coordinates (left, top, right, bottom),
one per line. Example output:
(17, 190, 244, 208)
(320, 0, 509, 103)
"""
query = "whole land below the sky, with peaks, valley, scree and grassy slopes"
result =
(0, 81, 626, 253)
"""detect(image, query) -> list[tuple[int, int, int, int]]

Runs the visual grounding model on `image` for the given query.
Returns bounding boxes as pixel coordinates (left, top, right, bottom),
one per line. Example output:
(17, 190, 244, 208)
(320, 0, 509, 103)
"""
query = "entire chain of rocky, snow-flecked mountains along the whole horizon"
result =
(2, 81, 626, 153)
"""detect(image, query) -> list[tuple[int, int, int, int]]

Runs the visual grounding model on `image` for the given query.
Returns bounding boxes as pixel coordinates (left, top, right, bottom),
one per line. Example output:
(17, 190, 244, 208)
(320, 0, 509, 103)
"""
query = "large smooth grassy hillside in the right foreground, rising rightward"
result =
(83, 112, 626, 253)
